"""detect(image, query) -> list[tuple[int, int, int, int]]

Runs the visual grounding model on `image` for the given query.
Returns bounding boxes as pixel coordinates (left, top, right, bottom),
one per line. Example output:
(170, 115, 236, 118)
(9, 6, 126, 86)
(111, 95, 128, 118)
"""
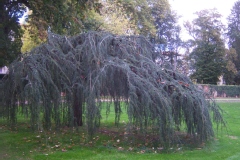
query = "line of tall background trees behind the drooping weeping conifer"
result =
(0, 0, 240, 85)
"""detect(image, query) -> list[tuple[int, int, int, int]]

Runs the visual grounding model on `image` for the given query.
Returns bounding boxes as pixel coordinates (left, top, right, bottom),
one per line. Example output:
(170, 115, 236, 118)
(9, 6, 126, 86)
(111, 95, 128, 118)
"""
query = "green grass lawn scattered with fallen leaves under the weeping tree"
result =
(0, 103, 240, 160)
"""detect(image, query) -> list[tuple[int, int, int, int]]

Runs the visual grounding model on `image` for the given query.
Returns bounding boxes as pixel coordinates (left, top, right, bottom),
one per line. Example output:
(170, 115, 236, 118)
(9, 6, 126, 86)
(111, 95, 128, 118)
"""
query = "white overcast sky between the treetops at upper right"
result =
(169, 0, 237, 38)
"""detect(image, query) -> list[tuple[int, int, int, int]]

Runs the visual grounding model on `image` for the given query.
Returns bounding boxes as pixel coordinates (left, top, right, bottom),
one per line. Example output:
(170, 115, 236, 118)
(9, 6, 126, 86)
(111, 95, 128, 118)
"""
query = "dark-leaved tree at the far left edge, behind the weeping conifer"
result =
(0, 0, 25, 67)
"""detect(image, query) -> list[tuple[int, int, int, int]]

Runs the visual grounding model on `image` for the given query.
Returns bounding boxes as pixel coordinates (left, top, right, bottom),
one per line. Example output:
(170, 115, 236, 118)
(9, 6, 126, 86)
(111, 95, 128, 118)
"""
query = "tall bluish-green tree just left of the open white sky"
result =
(149, 0, 181, 69)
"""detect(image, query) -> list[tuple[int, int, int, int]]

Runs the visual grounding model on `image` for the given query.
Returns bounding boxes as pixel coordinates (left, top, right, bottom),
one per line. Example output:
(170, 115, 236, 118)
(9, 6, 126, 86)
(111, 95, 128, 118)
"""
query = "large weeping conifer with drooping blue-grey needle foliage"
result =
(0, 32, 224, 144)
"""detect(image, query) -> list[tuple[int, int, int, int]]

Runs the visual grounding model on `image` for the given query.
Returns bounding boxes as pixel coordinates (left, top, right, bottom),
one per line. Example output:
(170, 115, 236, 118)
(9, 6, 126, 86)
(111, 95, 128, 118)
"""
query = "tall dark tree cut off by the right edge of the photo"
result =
(227, 1, 240, 85)
